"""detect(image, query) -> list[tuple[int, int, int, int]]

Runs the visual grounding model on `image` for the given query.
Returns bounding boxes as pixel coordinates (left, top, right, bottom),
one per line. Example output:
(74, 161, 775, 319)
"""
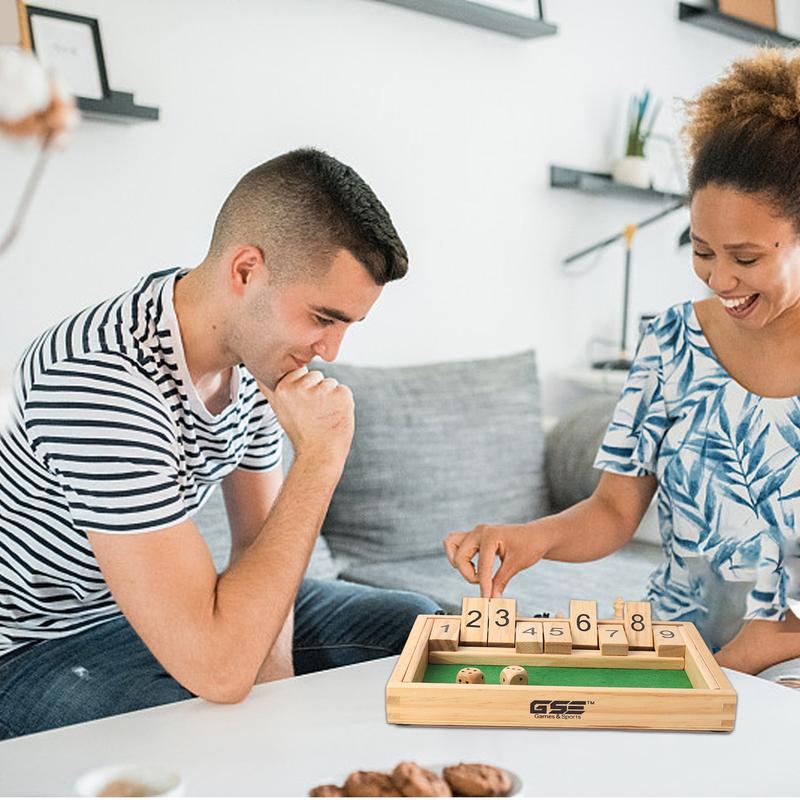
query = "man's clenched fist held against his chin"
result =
(259, 367, 355, 465)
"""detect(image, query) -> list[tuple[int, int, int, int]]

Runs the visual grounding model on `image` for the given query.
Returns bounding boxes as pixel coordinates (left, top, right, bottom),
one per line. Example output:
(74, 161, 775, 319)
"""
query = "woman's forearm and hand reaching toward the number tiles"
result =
(444, 472, 656, 597)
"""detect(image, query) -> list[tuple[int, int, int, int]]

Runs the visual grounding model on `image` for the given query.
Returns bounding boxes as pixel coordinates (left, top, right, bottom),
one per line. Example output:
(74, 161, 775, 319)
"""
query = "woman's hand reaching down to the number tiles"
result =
(444, 522, 549, 597)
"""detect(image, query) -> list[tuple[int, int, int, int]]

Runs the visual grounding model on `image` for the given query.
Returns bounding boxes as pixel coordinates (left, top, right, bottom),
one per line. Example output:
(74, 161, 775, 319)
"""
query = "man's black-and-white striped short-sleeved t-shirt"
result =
(0, 269, 281, 661)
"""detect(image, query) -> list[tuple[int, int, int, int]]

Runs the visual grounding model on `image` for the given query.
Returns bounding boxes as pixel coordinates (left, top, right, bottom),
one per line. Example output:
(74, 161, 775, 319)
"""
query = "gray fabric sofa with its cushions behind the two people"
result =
(196, 351, 660, 616)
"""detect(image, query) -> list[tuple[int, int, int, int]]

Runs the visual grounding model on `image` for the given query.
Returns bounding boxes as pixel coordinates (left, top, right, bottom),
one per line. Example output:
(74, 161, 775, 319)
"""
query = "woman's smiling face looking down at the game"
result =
(691, 184, 800, 330)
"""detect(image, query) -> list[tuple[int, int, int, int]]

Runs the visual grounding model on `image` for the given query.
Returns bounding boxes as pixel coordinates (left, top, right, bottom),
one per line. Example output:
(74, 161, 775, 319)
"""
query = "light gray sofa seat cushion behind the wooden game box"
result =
(340, 542, 661, 619)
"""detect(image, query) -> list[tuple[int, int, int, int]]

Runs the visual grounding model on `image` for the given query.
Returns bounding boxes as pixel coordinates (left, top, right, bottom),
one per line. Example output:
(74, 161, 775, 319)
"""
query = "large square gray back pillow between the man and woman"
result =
(314, 351, 548, 565)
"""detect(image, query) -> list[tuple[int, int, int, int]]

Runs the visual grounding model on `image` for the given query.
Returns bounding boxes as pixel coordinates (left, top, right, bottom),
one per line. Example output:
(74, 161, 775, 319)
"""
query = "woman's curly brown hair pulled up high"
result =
(683, 47, 800, 232)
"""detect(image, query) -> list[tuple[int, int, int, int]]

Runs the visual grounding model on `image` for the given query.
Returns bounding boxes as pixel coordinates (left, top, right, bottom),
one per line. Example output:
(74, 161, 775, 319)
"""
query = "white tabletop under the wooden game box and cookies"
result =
(0, 659, 800, 796)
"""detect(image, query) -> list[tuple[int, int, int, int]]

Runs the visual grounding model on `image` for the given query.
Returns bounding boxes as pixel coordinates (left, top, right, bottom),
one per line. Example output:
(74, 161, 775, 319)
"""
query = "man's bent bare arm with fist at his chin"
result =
(89, 370, 353, 702)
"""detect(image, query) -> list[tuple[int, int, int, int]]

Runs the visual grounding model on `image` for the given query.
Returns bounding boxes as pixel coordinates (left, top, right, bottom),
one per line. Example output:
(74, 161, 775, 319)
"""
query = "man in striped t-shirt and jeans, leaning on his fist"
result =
(0, 150, 436, 738)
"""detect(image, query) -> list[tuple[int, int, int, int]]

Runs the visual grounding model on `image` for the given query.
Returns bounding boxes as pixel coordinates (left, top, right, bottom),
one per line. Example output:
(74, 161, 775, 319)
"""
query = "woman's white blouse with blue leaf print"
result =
(595, 303, 800, 648)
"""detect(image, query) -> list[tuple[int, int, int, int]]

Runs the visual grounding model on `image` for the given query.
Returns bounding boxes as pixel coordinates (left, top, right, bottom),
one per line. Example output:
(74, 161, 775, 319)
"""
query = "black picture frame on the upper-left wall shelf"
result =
(25, 4, 111, 100)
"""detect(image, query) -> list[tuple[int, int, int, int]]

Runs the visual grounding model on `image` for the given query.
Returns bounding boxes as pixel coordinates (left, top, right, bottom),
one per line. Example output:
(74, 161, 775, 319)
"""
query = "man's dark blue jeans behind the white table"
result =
(0, 578, 438, 739)
